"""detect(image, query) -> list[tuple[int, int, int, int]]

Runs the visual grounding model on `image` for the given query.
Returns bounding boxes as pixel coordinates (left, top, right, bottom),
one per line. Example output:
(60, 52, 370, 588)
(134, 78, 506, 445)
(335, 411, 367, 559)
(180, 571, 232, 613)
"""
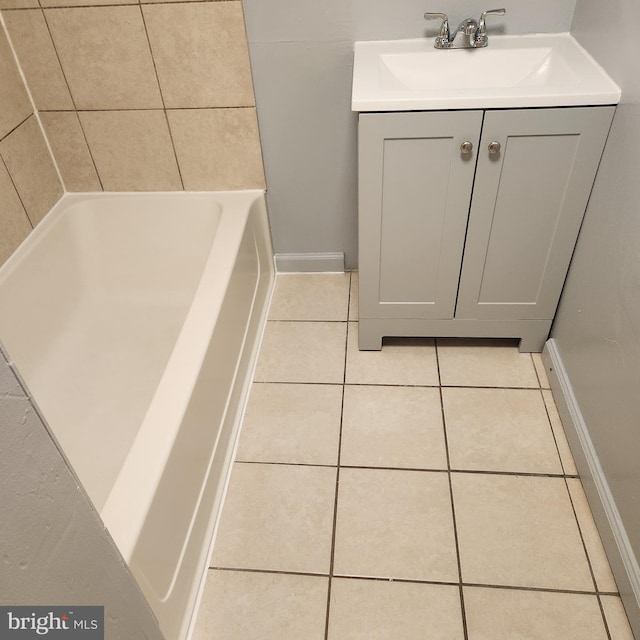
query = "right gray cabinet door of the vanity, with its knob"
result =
(456, 107, 615, 320)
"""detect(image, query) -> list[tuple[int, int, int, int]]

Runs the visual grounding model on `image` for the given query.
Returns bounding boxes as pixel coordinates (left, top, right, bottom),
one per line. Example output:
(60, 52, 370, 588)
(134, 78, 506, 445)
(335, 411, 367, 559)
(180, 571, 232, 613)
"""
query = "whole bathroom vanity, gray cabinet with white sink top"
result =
(353, 34, 619, 351)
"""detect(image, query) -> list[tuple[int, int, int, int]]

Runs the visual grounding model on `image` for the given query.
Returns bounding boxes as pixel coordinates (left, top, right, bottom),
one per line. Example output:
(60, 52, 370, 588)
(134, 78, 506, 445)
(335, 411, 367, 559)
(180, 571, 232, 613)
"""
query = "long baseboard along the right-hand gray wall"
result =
(542, 339, 640, 637)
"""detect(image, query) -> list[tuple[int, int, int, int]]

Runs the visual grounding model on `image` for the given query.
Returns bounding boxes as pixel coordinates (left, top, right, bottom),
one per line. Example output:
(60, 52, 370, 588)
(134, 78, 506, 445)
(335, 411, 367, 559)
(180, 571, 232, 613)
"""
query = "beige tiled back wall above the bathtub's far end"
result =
(0, 0, 265, 191)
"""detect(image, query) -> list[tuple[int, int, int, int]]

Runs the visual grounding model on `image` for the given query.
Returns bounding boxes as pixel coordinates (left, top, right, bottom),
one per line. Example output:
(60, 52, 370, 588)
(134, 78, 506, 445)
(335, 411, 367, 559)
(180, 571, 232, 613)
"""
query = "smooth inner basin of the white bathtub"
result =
(0, 197, 221, 511)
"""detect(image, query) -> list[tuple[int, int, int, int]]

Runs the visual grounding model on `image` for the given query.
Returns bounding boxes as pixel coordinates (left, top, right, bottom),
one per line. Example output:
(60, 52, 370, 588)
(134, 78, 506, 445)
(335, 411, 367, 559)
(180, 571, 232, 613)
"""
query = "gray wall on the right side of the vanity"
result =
(552, 0, 640, 633)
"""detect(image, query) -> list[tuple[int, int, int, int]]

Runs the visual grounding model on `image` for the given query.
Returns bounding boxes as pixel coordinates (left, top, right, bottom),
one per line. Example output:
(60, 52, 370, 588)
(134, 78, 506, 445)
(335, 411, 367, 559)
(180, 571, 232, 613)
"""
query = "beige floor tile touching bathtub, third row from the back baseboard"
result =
(236, 383, 342, 465)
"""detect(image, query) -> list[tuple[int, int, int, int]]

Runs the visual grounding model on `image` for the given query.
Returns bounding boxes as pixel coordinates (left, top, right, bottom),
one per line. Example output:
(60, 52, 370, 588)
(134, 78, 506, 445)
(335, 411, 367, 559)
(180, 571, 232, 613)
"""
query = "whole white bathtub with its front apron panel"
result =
(0, 191, 274, 640)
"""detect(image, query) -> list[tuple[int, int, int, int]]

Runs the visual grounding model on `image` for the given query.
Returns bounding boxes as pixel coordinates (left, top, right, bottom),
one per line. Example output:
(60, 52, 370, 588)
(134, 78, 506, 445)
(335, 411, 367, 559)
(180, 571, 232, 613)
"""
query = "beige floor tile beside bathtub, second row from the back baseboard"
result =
(254, 322, 347, 384)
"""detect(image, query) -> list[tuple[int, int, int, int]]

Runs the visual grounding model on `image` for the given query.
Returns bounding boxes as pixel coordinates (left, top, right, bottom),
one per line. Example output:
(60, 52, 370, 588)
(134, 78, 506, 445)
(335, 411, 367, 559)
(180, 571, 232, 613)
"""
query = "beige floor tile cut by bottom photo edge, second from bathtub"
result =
(328, 578, 464, 640)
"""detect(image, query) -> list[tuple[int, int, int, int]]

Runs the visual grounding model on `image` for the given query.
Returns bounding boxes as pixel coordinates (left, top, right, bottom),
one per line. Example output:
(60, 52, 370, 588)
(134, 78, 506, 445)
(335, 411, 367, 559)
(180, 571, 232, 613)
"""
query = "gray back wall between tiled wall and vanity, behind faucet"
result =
(243, 0, 575, 268)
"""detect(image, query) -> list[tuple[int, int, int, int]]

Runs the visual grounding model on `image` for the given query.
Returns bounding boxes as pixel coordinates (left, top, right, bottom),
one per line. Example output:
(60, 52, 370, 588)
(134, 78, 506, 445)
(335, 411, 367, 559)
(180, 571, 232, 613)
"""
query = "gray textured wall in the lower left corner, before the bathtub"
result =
(0, 354, 164, 640)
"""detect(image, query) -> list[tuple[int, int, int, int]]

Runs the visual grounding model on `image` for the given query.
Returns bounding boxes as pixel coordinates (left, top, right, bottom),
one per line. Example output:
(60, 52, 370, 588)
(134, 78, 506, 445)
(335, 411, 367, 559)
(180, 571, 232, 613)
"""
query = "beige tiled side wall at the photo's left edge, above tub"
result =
(0, 21, 63, 264)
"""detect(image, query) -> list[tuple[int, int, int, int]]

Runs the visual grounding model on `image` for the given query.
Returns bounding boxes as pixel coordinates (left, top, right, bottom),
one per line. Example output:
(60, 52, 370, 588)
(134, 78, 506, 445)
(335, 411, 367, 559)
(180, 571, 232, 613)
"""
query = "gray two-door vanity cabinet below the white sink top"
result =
(358, 107, 614, 351)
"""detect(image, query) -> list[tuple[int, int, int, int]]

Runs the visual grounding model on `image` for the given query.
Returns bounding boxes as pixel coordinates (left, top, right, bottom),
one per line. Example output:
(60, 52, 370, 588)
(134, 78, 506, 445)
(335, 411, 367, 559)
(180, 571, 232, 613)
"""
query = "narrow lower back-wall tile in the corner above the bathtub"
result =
(40, 111, 102, 191)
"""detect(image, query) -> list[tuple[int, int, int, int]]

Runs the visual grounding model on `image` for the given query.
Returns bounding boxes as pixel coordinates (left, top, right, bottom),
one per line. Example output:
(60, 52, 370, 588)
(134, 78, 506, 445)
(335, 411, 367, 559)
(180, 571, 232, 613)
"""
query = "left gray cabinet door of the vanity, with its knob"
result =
(358, 111, 482, 318)
